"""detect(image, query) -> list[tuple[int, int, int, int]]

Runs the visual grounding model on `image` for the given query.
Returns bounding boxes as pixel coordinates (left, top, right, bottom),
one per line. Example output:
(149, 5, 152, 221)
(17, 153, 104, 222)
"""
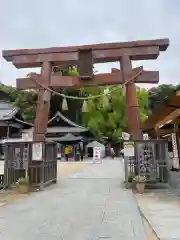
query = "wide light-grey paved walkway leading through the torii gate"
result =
(0, 160, 147, 240)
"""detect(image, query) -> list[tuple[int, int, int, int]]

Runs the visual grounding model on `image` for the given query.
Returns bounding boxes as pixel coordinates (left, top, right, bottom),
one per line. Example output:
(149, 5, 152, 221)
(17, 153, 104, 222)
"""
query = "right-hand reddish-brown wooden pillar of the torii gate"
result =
(120, 56, 141, 140)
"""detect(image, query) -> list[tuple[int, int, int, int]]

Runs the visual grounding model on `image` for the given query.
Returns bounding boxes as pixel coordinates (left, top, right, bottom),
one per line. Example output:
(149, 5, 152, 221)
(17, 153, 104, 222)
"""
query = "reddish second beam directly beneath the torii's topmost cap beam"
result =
(12, 46, 159, 68)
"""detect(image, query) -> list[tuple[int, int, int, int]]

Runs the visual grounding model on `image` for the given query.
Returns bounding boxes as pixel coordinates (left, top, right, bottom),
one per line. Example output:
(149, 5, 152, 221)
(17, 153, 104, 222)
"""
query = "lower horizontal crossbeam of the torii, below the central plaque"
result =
(16, 68, 159, 89)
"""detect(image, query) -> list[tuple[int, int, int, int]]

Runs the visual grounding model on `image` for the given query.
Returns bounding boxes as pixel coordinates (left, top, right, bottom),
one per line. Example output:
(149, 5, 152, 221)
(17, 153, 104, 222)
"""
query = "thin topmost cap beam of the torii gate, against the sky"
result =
(2, 38, 169, 61)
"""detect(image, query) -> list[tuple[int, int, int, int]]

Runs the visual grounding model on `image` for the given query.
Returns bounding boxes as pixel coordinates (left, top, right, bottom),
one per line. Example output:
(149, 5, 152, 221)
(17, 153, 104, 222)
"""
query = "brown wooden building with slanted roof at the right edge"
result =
(142, 91, 180, 191)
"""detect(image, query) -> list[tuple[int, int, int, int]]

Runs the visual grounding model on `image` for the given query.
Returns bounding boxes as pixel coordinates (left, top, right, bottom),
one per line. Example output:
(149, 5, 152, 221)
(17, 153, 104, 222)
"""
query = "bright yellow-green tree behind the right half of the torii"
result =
(84, 87, 149, 140)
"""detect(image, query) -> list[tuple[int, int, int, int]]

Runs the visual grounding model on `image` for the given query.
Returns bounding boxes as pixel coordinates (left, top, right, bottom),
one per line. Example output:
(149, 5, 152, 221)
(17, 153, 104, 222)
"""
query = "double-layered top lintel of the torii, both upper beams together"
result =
(3, 38, 169, 68)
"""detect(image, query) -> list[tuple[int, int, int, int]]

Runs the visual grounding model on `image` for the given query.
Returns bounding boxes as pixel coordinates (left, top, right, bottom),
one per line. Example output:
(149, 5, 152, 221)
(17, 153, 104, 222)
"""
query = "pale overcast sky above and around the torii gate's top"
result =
(0, 0, 180, 86)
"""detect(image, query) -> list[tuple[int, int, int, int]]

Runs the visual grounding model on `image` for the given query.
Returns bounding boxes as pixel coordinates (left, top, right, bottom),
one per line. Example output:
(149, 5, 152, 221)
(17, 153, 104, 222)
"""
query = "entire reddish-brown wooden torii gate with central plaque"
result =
(3, 39, 169, 141)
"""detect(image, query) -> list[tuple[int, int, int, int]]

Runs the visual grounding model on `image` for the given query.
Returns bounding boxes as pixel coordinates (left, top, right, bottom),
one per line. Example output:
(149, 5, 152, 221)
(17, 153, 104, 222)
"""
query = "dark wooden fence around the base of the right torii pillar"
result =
(124, 140, 169, 188)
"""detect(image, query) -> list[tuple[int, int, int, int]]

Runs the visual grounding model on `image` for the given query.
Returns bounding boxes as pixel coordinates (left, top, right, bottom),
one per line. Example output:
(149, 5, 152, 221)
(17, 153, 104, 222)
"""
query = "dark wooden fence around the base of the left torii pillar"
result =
(3, 142, 57, 189)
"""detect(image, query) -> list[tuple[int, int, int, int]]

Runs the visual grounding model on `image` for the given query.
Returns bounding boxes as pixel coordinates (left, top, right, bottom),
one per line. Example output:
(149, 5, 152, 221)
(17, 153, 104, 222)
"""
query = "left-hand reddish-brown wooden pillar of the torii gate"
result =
(33, 62, 51, 141)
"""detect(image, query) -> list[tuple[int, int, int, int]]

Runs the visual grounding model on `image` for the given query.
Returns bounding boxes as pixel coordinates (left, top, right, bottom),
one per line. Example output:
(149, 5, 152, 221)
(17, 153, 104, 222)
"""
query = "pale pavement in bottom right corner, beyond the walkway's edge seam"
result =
(136, 189, 180, 240)
